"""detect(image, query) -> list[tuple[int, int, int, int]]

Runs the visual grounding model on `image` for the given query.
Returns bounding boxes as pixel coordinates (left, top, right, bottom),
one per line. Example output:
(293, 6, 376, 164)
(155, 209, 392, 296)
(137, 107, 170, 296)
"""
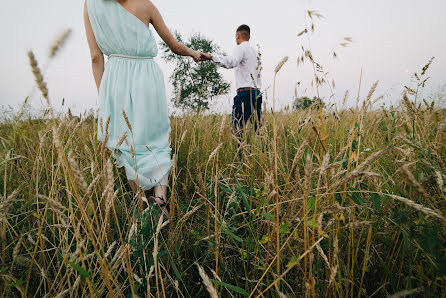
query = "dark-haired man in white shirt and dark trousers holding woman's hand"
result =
(202, 25, 262, 137)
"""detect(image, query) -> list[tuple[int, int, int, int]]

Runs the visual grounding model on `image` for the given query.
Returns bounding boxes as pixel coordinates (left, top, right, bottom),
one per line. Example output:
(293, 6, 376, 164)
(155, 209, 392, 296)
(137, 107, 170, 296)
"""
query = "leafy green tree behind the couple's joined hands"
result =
(161, 32, 231, 112)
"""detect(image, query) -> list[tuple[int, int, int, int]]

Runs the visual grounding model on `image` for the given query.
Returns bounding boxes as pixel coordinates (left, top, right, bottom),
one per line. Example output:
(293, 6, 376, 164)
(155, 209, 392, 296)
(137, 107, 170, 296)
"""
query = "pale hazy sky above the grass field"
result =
(0, 0, 446, 113)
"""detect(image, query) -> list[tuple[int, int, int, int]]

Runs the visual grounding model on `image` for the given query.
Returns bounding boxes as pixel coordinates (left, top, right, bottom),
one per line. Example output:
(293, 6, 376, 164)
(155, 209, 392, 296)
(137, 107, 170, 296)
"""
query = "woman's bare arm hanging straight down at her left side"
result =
(84, 1, 104, 92)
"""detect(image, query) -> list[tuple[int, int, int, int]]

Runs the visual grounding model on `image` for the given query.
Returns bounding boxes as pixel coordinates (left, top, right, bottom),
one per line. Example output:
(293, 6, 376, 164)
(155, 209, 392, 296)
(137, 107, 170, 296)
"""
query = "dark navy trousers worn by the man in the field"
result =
(232, 88, 262, 138)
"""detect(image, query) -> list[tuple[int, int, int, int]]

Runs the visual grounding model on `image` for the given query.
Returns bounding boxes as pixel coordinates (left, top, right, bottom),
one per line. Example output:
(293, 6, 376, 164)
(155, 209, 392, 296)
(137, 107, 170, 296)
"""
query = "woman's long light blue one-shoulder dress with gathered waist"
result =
(87, 0, 172, 190)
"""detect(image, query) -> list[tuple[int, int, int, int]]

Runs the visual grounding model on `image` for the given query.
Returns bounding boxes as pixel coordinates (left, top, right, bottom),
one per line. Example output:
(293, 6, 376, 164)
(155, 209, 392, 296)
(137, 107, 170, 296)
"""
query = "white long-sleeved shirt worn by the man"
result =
(212, 41, 262, 89)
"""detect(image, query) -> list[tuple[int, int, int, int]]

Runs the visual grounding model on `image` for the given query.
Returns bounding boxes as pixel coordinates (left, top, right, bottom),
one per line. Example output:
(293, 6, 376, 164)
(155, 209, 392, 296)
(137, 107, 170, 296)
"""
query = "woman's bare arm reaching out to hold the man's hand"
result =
(150, 2, 202, 61)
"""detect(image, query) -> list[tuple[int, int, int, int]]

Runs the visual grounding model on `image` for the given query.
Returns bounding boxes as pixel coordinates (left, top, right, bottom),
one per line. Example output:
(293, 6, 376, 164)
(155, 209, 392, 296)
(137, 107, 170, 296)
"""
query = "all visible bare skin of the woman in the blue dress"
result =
(84, 0, 206, 216)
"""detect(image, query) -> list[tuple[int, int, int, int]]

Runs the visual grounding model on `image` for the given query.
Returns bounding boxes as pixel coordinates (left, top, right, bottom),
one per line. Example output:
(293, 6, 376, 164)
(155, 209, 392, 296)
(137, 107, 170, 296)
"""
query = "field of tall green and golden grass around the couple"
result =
(0, 25, 446, 297)
